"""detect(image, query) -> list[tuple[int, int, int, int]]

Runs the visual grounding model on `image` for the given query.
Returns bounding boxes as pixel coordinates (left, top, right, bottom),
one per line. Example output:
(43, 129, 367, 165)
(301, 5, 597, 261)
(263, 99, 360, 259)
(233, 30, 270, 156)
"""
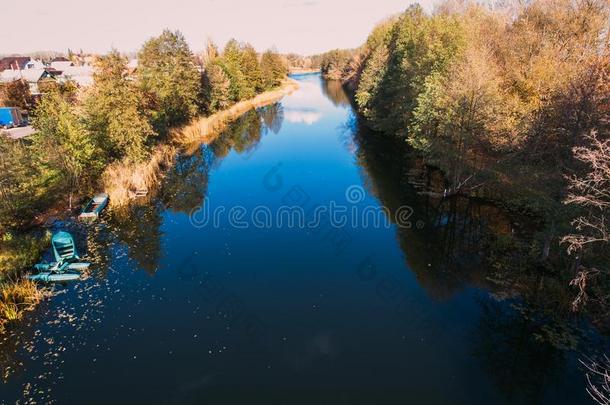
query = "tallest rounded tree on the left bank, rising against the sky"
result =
(138, 30, 201, 131)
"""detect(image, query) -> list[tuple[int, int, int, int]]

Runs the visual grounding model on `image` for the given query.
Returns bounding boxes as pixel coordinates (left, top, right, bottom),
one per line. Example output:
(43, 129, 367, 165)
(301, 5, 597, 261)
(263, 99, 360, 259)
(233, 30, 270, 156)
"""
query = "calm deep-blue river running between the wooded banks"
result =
(0, 75, 607, 404)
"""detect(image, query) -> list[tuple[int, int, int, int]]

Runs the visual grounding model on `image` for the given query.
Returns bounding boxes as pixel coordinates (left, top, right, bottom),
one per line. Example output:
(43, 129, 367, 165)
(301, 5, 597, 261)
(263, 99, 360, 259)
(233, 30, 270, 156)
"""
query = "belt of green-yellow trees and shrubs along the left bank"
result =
(0, 31, 287, 329)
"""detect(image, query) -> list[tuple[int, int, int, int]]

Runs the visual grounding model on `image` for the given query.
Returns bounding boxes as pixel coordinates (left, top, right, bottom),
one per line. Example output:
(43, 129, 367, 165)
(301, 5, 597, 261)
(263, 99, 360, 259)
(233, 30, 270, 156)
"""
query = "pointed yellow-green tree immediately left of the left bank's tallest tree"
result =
(85, 51, 155, 162)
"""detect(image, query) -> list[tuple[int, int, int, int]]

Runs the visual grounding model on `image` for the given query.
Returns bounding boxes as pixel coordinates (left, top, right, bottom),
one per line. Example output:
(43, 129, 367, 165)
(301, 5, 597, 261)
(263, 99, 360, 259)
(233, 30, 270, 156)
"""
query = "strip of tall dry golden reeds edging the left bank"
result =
(102, 79, 298, 207)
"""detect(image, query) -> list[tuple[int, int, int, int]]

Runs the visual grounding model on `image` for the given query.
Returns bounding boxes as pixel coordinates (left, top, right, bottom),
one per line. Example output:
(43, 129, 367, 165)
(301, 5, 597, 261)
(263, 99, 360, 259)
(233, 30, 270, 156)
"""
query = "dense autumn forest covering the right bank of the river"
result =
(320, 0, 610, 327)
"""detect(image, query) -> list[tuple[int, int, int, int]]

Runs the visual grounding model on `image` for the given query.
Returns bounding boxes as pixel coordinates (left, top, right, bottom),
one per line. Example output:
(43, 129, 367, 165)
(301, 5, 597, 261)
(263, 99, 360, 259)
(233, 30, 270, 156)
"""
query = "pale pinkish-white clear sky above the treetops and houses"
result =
(0, 0, 434, 55)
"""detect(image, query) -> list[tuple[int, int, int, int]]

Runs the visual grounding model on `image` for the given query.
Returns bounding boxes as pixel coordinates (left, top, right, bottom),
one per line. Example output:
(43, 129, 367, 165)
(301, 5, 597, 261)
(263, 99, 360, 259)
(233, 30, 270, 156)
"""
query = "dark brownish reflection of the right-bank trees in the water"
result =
(354, 111, 584, 314)
